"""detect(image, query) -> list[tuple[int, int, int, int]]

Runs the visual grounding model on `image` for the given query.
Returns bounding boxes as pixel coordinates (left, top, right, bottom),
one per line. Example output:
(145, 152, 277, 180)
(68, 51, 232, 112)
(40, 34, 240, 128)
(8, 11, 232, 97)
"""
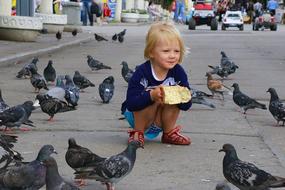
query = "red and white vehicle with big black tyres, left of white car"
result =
(186, 0, 218, 30)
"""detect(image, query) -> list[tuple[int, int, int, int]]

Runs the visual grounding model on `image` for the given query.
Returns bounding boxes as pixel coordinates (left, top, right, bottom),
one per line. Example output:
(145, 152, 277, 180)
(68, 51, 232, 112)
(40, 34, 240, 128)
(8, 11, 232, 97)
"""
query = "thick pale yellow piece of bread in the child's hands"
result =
(162, 85, 191, 105)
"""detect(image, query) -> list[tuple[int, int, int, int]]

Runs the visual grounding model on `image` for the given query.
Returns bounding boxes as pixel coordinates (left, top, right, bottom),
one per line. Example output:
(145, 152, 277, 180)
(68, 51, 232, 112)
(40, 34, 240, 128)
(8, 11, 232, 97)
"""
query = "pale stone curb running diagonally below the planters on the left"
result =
(0, 36, 93, 67)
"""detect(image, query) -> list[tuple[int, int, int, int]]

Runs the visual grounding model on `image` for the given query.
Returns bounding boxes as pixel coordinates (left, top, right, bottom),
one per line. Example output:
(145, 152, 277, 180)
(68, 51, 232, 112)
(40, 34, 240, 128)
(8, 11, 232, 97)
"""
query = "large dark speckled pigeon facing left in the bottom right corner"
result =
(219, 144, 285, 190)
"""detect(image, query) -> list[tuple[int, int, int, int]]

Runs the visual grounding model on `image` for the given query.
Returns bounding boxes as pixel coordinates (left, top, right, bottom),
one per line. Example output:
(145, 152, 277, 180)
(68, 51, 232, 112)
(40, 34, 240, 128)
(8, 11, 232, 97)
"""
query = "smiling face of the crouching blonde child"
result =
(150, 40, 180, 70)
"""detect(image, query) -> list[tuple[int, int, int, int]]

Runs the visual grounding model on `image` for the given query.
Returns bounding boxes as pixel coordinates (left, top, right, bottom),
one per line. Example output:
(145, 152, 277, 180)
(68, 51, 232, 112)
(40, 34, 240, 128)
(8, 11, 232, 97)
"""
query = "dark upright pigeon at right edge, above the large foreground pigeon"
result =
(267, 88, 285, 126)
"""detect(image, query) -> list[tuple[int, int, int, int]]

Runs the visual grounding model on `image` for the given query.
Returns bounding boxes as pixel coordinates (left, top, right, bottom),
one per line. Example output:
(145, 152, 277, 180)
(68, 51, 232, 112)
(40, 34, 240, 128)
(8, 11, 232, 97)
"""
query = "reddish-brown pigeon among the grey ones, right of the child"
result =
(206, 73, 232, 100)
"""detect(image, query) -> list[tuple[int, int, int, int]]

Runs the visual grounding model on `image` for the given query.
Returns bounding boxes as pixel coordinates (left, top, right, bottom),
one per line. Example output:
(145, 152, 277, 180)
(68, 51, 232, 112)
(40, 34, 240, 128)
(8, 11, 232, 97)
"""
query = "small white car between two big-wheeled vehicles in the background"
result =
(222, 11, 243, 30)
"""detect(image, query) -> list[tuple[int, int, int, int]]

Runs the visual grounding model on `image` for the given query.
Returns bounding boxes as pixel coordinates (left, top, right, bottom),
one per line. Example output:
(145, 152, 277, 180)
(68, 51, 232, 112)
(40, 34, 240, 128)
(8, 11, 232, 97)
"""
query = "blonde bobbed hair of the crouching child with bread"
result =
(144, 22, 186, 63)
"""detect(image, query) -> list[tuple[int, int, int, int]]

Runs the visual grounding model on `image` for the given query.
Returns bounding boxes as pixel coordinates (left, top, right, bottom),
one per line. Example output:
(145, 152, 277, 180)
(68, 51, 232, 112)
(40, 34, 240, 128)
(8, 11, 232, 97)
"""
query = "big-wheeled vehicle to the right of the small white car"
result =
(252, 12, 277, 31)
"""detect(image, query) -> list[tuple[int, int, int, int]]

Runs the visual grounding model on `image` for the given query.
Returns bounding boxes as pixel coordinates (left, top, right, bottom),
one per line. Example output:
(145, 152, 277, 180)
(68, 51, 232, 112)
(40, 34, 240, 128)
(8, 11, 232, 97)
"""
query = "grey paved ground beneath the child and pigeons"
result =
(0, 25, 285, 190)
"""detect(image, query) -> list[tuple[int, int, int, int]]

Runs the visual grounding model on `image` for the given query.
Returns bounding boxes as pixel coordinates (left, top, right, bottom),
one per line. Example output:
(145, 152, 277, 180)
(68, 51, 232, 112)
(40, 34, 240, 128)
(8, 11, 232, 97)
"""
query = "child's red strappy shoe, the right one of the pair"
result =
(161, 126, 191, 145)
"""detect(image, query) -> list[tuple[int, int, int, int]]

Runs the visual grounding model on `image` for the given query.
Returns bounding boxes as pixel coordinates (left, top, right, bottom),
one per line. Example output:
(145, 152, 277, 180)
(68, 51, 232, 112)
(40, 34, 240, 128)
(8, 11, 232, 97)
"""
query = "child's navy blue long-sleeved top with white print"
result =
(125, 61, 192, 112)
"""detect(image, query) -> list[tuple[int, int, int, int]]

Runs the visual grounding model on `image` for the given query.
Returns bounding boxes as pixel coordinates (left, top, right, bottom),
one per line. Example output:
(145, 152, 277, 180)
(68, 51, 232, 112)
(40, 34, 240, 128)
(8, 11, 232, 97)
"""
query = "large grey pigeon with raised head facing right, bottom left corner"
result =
(1, 145, 57, 190)
